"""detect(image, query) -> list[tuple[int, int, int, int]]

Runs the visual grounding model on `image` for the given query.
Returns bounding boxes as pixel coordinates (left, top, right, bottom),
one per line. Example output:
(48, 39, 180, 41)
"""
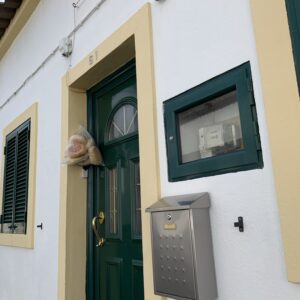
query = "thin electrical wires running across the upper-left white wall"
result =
(0, 0, 106, 111)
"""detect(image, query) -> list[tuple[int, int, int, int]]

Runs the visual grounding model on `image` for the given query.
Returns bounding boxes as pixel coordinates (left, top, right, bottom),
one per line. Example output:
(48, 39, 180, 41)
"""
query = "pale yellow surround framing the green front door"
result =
(58, 4, 161, 300)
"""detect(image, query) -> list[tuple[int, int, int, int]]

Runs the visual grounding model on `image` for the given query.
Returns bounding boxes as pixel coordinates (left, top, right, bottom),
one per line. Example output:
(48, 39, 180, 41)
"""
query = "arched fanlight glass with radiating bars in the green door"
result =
(108, 104, 138, 141)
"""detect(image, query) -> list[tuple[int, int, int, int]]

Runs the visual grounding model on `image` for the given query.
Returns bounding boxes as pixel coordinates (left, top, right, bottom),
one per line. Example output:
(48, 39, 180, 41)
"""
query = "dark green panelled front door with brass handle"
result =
(88, 63, 144, 300)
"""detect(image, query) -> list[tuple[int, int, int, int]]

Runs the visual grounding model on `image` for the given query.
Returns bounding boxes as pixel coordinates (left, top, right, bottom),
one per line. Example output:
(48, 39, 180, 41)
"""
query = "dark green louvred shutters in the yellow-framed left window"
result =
(2, 121, 30, 233)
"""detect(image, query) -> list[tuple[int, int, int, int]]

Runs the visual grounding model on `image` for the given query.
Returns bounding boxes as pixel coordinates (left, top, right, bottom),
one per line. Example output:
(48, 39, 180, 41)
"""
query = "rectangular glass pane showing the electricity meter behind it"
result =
(178, 90, 244, 163)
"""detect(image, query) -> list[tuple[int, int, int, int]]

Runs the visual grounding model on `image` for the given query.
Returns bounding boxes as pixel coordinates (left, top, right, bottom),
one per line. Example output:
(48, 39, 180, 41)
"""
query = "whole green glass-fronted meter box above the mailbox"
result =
(164, 63, 263, 181)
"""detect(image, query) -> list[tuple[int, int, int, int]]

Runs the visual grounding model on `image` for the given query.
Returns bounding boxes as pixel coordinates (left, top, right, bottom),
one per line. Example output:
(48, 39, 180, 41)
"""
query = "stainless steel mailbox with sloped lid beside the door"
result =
(146, 193, 217, 300)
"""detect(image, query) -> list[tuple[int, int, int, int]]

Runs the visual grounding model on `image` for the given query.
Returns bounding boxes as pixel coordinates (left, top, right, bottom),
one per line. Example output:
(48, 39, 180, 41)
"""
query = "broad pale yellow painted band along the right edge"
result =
(251, 0, 300, 283)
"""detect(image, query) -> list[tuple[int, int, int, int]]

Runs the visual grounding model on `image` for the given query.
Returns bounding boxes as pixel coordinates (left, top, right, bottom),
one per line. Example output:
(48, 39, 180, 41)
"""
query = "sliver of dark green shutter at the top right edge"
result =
(285, 0, 300, 89)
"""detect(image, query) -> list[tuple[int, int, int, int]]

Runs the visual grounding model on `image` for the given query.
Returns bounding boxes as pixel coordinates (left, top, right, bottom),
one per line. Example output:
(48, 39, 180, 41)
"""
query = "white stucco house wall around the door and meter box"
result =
(0, 0, 300, 300)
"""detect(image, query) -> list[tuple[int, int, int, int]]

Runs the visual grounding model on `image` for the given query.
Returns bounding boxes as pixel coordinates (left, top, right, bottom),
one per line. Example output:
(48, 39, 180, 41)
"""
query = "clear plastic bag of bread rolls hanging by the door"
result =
(64, 126, 103, 166)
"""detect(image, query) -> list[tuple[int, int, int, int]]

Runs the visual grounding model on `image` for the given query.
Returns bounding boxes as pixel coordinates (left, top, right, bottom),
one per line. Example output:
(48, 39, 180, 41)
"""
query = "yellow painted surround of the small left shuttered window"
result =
(0, 103, 38, 249)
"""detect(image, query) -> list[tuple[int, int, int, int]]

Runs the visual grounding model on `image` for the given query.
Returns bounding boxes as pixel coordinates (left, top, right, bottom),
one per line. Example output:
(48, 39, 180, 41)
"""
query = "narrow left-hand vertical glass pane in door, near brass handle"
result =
(109, 168, 119, 234)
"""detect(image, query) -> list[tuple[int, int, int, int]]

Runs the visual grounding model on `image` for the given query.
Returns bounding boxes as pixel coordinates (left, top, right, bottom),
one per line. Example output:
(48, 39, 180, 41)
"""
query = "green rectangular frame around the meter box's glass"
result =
(164, 62, 263, 182)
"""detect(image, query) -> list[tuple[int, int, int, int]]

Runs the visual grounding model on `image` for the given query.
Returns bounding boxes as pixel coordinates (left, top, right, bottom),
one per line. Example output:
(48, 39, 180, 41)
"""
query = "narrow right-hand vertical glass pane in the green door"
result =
(134, 162, 142, 236)
